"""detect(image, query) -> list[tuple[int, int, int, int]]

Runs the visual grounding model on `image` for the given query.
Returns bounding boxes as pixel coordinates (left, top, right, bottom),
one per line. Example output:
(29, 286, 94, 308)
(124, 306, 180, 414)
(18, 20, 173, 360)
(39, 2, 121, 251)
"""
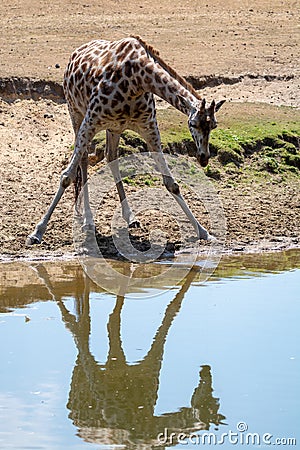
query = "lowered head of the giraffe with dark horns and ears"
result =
(188, 99, 225, 167)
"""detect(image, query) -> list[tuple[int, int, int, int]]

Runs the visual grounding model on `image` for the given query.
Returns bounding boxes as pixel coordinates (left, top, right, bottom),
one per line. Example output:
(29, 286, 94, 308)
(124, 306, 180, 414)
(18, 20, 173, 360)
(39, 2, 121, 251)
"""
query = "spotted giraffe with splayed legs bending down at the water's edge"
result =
(26, 36, 225, 245)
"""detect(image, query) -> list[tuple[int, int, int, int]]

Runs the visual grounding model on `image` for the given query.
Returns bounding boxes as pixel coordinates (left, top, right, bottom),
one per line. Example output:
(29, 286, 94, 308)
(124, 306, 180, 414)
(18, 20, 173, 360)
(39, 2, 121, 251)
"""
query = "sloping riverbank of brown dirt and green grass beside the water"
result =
(0, 99, 300, 259)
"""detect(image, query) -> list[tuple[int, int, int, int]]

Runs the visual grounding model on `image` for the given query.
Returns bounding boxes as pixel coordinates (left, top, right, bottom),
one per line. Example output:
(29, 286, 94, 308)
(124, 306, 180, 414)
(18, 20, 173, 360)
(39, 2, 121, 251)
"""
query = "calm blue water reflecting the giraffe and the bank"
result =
(0, 251, 300, 450)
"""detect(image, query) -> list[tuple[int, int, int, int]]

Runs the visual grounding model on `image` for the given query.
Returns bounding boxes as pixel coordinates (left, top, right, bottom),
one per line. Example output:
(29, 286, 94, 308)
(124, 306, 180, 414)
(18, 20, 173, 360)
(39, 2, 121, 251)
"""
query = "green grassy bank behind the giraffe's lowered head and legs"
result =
(95, 103, 300, 186)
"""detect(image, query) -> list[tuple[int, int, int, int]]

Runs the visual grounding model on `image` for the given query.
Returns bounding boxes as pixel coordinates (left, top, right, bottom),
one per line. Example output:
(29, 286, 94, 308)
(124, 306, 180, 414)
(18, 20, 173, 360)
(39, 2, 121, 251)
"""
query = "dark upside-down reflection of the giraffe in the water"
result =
(36, 266, 225, 449)
